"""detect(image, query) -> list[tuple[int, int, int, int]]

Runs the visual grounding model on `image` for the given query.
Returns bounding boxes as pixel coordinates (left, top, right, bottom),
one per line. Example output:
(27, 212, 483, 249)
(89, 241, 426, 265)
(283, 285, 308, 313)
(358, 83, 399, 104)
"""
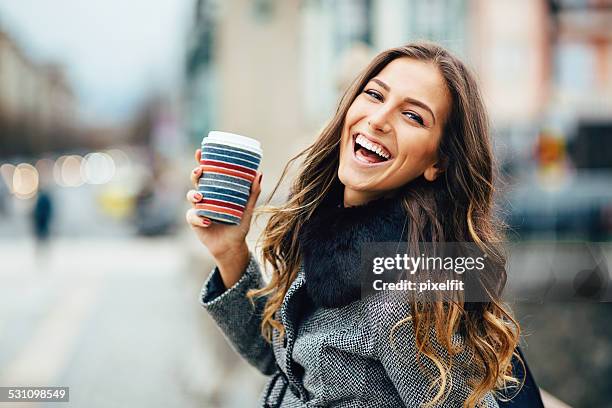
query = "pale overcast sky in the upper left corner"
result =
(0, 0, 193, 122)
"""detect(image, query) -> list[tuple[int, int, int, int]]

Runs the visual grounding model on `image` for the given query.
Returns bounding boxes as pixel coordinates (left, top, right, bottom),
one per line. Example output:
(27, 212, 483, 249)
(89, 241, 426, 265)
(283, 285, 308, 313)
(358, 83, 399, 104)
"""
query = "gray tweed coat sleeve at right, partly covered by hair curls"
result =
(368, 295, 499, 408)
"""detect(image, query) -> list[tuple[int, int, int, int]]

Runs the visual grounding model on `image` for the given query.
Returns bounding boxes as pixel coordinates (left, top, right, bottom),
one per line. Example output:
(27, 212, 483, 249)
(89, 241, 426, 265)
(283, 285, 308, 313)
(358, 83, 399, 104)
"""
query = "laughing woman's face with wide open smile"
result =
(338, 57, 451, 206)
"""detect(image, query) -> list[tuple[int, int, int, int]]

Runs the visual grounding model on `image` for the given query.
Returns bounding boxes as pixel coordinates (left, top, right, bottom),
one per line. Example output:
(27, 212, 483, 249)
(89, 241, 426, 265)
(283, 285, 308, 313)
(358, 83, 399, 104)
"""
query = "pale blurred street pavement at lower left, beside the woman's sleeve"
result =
(0, 233, 268, 407)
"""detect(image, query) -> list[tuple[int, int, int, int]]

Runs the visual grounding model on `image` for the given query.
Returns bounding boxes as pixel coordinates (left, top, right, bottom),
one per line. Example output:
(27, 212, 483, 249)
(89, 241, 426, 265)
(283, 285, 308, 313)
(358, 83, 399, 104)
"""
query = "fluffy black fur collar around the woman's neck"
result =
(300, 180, 408, 307)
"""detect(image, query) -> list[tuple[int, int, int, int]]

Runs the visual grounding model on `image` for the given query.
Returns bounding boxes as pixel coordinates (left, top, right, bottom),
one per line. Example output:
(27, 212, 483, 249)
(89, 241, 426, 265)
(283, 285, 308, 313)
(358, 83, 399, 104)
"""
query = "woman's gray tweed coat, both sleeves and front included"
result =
(200, 253, 498, 408)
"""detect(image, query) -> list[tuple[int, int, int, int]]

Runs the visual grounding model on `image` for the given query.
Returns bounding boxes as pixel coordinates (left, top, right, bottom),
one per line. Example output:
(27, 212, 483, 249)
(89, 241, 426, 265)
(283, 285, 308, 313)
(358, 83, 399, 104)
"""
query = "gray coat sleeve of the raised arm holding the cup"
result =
(200, 251, 276, 375)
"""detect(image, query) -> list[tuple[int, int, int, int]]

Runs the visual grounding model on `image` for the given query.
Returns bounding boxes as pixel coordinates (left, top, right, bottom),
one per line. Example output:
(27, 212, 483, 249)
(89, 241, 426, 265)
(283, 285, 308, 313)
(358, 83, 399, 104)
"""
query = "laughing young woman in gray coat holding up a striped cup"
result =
(186, 43, 540, 408)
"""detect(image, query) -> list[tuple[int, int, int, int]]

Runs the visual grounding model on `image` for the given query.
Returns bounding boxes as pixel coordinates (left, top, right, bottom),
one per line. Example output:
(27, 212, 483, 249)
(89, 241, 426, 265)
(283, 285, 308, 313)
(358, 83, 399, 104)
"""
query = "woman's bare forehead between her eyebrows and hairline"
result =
(375, 57, 451, 117)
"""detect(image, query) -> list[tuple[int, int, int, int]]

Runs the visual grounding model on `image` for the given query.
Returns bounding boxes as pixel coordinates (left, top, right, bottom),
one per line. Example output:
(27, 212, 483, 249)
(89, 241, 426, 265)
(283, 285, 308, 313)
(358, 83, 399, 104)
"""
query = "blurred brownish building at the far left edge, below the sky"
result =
(0, 31, 76, 156)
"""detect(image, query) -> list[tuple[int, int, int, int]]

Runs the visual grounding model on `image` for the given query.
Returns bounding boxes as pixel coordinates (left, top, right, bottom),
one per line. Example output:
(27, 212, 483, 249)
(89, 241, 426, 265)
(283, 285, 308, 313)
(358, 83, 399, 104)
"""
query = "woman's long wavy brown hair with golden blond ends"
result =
(248, 42, 520, 407)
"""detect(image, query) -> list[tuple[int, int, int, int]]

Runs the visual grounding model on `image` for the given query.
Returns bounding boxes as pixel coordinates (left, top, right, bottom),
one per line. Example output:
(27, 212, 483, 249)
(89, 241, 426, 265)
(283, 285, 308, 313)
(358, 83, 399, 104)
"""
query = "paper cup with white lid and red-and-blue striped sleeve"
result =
(196, 131, 262, 225)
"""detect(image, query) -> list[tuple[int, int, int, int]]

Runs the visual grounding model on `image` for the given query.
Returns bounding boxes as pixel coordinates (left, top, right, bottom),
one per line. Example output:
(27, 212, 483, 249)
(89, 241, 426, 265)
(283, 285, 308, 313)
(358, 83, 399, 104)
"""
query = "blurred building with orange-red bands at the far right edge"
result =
(548, 0, 612, 170)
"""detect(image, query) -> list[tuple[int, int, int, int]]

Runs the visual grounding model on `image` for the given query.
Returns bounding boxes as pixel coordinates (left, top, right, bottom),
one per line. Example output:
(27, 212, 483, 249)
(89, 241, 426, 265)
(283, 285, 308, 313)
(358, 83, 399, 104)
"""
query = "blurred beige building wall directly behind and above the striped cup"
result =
(185, 0, 304, 190)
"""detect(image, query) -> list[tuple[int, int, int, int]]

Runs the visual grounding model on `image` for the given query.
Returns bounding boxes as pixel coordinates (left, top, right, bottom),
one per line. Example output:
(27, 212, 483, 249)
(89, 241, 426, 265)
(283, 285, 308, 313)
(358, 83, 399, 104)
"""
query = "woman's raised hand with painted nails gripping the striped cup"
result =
(185, 149, 262, 288)
